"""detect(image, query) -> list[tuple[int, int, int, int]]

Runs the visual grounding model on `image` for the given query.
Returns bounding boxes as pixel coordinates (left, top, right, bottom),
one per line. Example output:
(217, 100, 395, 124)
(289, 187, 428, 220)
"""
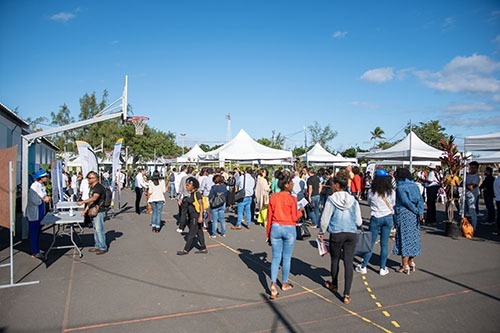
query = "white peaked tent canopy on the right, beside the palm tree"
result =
(364, 132, 443, 161)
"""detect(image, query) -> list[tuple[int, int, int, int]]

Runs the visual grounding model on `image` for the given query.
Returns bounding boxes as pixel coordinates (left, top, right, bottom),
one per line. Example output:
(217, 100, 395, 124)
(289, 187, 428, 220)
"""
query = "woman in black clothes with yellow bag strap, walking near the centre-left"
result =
(177, 177, 208, 256)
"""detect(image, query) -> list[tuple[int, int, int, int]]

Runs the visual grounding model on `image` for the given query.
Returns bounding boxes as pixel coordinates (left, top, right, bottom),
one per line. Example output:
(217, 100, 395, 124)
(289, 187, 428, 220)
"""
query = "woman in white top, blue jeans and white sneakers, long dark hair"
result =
(356, 169, 396, 276)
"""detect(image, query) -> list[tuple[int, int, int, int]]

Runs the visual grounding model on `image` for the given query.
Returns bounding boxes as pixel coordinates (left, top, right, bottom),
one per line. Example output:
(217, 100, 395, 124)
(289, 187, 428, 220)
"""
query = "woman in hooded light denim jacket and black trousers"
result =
(318, 170, 363, 304)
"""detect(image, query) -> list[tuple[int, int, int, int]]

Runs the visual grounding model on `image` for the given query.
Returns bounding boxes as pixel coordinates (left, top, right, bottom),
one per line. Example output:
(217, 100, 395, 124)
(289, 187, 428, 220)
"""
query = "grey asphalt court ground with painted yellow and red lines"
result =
(0, 190, 500, 332)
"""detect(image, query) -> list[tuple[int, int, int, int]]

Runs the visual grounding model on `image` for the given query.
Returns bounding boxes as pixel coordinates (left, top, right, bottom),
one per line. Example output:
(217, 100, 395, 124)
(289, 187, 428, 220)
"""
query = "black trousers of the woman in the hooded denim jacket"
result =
(330, 232, 356, 295)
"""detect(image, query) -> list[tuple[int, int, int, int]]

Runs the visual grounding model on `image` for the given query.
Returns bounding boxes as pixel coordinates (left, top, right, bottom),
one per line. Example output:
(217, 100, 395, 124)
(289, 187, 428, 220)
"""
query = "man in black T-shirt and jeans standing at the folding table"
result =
(77, 171, 108, 255)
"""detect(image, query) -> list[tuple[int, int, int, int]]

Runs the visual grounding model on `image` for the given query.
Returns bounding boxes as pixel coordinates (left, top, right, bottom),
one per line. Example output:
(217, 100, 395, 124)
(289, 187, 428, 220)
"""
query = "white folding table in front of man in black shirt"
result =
(41, 211, 84, 258)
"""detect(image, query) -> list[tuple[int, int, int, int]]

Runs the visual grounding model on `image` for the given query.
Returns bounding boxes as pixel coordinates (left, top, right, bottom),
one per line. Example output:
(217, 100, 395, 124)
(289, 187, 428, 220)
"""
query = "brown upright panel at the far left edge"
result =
(0, 146, 17, 229)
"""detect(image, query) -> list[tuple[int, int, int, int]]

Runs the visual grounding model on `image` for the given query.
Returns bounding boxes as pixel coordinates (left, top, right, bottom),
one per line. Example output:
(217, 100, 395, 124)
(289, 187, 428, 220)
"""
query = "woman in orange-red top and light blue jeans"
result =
(266, 172, 300, 300)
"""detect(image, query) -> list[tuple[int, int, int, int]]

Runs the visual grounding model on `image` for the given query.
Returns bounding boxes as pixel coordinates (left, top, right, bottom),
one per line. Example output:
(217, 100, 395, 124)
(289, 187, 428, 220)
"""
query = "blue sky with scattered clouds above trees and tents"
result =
(0, 0, 500, 151)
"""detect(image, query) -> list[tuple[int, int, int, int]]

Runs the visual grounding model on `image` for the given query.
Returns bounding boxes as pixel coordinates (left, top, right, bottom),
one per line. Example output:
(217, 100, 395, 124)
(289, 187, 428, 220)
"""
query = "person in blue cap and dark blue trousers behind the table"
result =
(26, 169, 50, 260)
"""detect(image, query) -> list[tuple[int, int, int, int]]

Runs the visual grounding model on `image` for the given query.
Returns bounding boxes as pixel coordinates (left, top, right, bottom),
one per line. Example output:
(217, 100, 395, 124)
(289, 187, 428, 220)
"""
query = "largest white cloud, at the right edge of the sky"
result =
(415, 54, 500, 94)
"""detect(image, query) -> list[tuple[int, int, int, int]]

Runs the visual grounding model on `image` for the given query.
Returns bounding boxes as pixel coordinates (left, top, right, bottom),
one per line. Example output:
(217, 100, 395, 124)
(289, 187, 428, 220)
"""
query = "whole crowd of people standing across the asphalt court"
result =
(27, 162, 500, 304)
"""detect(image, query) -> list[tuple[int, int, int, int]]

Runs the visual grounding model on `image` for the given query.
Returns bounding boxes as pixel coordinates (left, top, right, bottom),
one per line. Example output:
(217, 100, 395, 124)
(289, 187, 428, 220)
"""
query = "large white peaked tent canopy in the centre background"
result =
(198, 130, 292, 162)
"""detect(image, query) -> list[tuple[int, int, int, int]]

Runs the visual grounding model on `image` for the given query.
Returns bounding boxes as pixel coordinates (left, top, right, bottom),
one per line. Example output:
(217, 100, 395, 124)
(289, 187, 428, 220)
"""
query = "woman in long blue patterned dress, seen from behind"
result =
(392, 168, 424, 274)
